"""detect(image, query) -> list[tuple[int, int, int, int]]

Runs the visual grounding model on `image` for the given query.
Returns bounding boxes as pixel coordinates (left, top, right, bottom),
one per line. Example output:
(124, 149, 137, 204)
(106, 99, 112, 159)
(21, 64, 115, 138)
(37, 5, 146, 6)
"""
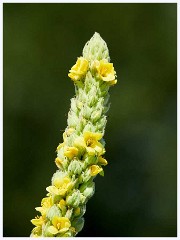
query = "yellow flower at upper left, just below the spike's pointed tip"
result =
(68, 57, 88, 81)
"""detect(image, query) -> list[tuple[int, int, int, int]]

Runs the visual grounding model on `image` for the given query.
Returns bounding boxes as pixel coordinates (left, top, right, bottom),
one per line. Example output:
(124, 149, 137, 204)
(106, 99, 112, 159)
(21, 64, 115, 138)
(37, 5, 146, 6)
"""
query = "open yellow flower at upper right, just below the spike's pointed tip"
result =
(93, 59, 117, 85)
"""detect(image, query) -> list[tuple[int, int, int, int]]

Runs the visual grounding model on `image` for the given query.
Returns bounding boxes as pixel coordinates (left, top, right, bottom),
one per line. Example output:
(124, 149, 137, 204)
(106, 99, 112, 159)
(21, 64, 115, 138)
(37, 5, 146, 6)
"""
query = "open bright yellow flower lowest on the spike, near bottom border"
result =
(48, 216, 71, 235)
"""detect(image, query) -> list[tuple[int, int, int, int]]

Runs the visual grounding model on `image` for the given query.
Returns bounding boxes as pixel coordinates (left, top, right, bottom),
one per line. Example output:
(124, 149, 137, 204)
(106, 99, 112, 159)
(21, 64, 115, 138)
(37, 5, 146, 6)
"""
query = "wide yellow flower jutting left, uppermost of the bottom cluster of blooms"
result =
(46, 177, 73, 196)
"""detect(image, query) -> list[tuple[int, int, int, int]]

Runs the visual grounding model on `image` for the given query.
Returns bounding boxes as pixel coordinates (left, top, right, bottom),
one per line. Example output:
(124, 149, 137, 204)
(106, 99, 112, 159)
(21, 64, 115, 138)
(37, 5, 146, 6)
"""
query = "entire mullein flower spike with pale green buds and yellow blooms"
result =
(31, 33, 117, 237)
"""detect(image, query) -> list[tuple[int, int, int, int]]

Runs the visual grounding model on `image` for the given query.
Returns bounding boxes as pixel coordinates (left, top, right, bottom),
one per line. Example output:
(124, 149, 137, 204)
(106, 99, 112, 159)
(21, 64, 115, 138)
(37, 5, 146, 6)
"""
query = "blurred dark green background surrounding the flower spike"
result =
(3, 3, 177, 237)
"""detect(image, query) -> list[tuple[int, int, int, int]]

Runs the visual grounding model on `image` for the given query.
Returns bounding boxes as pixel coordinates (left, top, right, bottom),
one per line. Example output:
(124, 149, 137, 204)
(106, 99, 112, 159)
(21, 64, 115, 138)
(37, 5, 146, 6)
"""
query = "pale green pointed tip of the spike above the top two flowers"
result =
(83, 32, 110, 61)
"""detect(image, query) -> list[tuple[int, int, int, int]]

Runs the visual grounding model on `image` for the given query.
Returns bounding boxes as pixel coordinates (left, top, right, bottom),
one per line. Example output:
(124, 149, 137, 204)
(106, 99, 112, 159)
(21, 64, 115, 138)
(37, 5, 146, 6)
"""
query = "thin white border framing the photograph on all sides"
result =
(0, 0, 180, 240)
